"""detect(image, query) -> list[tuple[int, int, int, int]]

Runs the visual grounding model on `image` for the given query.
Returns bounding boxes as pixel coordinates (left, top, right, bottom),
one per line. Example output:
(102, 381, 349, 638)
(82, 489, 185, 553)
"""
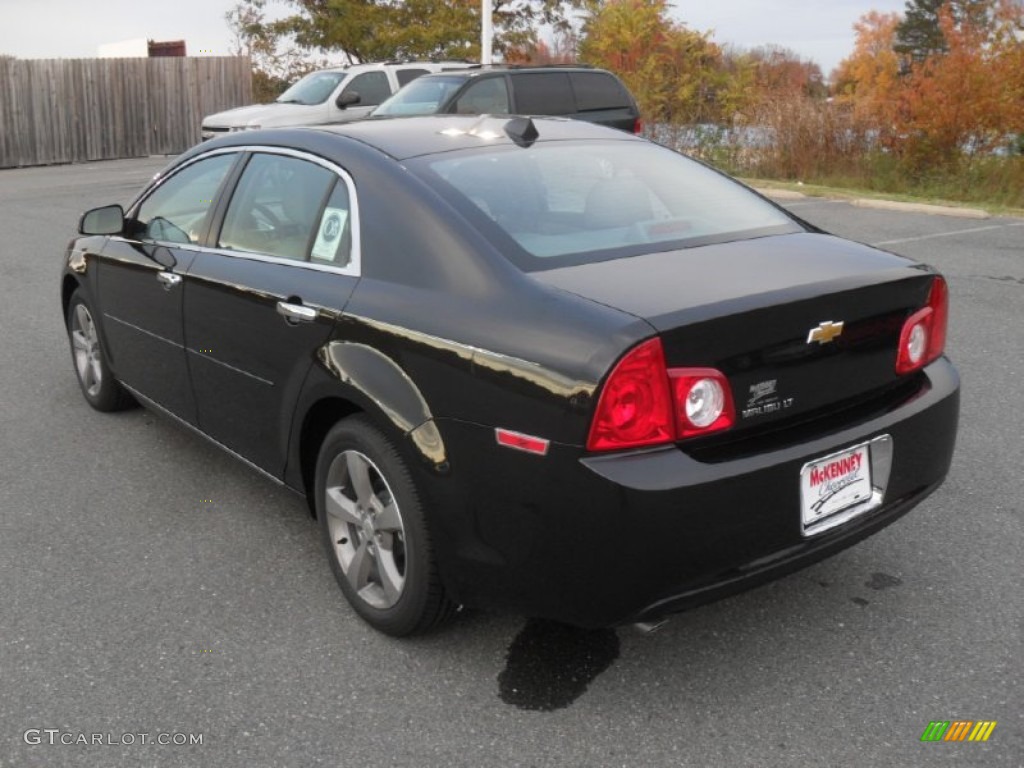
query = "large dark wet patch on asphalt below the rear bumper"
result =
(498, 618, 618, 712)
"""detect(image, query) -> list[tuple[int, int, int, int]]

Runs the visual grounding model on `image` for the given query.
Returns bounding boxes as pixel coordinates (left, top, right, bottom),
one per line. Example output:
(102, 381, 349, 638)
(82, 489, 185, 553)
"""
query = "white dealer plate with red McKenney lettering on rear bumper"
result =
(800, 442, 871, 534)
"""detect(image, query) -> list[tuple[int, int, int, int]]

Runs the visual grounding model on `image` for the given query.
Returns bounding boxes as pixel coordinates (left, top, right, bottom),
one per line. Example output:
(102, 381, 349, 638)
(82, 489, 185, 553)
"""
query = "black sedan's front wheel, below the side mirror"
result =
(66, 290, 135, 413)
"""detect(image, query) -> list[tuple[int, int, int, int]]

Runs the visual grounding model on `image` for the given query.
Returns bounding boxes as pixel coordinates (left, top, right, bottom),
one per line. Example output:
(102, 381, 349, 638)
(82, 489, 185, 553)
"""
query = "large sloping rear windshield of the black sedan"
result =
(414, 141, 804, 270)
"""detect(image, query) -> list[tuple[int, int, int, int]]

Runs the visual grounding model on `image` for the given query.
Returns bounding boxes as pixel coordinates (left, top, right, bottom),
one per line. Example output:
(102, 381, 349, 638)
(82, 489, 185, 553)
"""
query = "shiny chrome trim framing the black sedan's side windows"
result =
(123, 144, 362, 278)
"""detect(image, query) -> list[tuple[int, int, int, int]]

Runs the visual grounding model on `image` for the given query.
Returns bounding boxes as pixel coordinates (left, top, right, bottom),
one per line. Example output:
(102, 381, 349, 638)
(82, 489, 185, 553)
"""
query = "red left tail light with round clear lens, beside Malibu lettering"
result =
(587, 338, 735, 451)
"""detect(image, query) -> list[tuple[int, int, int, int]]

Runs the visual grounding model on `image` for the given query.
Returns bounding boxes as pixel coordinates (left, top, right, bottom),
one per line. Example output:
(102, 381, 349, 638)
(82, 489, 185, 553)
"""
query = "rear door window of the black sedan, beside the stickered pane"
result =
(217, 154, 337, 261)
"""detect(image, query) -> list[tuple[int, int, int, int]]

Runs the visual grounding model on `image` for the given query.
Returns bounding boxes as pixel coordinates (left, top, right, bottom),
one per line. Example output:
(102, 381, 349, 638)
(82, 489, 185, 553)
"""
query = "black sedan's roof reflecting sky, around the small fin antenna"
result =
(309, 115, 643, 160)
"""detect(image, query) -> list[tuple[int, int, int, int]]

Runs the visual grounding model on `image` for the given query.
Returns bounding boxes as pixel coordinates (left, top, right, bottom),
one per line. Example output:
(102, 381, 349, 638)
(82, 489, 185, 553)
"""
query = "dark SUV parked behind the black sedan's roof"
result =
(370, 67, 641, 133)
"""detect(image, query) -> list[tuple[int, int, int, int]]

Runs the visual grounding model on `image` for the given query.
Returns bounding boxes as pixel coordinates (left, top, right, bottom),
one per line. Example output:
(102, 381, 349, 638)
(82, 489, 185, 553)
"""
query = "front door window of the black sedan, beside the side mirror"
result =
(133, 153, 239, 244)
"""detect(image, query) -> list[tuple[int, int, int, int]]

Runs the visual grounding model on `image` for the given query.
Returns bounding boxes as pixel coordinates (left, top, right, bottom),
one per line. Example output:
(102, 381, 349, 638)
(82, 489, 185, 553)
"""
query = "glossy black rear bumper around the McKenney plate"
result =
(427, 358, 959, 627)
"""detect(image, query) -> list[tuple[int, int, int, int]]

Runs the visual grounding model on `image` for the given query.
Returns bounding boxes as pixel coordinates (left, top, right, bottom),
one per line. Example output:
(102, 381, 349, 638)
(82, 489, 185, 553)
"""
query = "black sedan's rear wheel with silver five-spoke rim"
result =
(315, 416, 454, 637)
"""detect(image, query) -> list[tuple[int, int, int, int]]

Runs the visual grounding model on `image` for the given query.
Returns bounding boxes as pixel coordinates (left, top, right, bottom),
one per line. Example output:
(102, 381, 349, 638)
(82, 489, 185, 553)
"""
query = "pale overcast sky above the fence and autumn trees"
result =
(0, 0, 905, 77)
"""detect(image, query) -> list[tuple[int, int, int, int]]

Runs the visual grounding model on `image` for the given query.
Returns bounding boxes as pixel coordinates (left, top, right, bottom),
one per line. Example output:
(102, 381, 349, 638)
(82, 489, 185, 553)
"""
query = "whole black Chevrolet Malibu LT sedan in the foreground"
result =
(60, 116, 959, 635)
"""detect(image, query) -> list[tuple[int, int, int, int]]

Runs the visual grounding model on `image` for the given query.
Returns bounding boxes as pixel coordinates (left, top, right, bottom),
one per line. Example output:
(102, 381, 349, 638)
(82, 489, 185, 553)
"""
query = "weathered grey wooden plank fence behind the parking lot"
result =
(0, 56, 252, 168)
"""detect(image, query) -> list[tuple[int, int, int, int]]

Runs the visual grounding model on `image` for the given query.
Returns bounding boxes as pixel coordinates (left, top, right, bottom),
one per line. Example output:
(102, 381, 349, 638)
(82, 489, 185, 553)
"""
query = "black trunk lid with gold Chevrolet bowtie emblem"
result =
(532, 233, 933, 435)
